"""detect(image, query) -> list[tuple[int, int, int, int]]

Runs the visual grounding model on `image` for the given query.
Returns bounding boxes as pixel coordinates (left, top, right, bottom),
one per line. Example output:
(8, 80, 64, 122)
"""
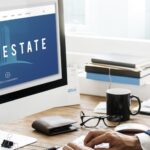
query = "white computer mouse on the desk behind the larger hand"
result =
(114, 123, 150, 134)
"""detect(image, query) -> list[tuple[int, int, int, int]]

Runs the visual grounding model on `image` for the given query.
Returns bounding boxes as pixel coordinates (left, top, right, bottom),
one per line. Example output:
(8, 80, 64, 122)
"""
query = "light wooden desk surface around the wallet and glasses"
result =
(0, 95, 150, 150)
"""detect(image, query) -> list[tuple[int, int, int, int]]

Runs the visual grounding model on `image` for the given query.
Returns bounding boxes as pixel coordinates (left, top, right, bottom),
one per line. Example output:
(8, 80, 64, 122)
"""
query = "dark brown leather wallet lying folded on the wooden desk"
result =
(32, 116, 78, 135)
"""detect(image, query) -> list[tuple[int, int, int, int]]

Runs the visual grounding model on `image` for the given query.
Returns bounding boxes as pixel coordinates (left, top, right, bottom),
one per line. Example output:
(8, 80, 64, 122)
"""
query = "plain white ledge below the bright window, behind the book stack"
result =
(66, 34, 150, 57)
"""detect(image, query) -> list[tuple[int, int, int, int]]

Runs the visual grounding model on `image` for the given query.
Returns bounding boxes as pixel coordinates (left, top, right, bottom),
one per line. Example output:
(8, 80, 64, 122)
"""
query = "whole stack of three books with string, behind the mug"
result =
(85, 54, 150, 85)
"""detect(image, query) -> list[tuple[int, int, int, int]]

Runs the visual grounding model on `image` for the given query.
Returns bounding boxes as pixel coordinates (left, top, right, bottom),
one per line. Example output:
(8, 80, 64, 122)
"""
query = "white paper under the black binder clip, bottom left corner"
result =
(0, 130, 37, 150)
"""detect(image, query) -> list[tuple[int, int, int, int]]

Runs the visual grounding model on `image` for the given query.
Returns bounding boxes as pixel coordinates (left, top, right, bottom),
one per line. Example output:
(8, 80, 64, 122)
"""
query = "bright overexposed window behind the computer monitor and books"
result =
(64, 0, 150, 39)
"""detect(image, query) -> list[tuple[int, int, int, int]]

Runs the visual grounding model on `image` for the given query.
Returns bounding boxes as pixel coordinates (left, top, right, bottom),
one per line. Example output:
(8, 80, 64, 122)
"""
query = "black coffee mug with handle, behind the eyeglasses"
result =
(106, 88, 141, 121)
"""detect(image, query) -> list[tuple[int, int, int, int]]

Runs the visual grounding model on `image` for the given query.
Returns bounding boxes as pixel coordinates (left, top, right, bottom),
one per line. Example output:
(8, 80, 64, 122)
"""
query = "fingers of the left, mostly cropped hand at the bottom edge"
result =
(63, 143, 93, 150)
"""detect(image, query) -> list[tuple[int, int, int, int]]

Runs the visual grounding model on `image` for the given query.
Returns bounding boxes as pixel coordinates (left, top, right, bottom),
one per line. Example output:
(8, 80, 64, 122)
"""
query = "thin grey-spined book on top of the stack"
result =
(91, 54, 150, 68)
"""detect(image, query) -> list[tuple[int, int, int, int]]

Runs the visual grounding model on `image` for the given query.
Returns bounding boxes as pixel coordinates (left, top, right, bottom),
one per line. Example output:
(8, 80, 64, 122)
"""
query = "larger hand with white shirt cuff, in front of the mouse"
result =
(84, 130, 142, 150)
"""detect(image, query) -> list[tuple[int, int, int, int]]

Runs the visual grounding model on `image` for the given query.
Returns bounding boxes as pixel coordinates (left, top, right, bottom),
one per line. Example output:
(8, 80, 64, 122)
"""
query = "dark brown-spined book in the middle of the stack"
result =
(85, 63, 150, 78)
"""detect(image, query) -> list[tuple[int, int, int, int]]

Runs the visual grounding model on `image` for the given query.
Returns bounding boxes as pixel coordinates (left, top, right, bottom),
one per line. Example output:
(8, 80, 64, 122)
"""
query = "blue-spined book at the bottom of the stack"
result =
(86, 72, 150, 85)
